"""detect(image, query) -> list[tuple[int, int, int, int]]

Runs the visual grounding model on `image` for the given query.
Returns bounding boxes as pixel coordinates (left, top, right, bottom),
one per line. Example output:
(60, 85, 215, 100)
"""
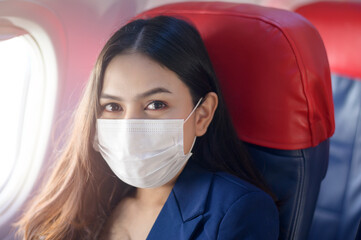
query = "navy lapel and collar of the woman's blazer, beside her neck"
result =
(147, 162, 213, 240)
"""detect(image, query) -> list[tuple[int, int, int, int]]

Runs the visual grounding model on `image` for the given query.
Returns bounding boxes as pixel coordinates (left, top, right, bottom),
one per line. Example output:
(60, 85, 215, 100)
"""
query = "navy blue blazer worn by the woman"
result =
(147, 162, 279, 240)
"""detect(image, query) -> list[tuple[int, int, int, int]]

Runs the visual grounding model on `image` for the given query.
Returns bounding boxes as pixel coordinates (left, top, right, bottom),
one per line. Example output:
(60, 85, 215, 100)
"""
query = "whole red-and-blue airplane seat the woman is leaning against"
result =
(136, 2, 334, 239)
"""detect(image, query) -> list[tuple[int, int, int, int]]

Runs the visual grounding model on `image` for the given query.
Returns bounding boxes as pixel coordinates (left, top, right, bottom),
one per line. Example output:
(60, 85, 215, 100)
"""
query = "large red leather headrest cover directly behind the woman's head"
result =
(137, 2, 334, 149)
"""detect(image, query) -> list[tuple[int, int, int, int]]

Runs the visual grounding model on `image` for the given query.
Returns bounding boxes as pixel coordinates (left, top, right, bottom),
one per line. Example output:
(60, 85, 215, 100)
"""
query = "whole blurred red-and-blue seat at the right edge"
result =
(296, 2, 361, 240)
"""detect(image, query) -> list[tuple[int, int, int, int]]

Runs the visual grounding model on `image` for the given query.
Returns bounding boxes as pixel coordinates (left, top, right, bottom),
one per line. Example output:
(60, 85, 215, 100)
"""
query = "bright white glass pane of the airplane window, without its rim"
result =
(0, 37, 32, 189)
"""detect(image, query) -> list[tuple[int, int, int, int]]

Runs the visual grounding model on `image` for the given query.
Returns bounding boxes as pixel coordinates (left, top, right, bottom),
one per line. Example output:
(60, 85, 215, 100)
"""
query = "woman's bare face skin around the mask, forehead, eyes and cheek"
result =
(99, 53, 197, 153)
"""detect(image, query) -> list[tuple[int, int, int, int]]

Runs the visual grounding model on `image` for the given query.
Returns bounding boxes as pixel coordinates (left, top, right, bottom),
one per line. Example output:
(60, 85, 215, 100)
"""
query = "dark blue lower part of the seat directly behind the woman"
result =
(245, 139, 329, 239)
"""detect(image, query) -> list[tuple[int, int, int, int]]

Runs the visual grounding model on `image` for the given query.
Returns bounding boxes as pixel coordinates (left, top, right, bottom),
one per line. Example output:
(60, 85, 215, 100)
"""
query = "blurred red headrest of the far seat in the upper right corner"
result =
(296, 2, 361, 78)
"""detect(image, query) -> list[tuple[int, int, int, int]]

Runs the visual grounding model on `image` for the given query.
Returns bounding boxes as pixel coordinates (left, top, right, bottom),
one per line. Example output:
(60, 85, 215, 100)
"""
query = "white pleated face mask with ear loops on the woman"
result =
(94, 98, 202, 188)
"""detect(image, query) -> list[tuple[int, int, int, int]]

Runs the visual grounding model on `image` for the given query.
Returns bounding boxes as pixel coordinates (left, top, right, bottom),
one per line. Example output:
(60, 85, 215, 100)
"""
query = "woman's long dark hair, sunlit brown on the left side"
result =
(18, 16, 270, 240)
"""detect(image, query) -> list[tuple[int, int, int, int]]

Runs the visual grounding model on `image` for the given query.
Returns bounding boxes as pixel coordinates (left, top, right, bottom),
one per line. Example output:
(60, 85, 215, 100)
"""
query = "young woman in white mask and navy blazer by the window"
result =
(19, 16, 278, 240)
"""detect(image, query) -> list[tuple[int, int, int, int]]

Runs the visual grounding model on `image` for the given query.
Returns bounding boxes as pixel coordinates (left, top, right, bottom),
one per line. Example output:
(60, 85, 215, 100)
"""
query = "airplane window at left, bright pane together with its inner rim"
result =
(0, 33, 46, 223)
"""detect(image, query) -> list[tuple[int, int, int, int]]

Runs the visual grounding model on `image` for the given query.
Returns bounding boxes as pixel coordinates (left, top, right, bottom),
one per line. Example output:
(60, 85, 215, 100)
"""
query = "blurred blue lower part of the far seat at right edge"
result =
(309, 74, 361, 240)
